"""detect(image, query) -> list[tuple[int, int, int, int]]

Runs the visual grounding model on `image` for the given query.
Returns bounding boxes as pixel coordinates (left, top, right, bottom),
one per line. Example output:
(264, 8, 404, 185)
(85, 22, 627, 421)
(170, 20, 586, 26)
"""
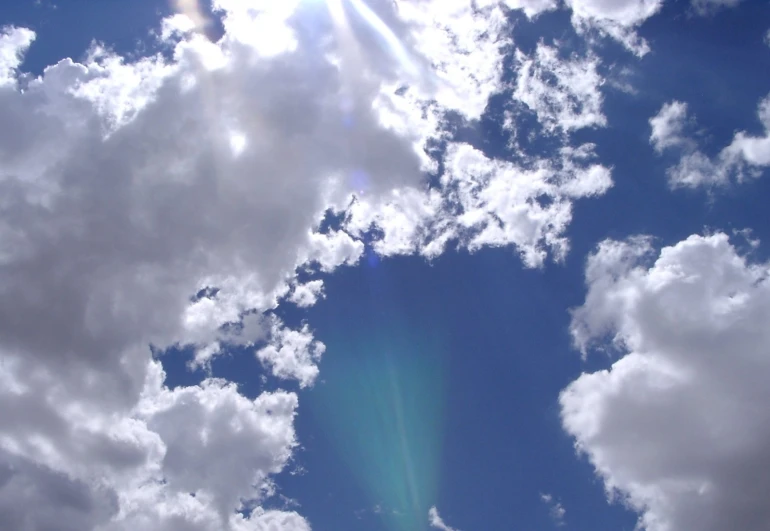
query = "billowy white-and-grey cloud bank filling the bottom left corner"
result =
(0, 353, 309, 531)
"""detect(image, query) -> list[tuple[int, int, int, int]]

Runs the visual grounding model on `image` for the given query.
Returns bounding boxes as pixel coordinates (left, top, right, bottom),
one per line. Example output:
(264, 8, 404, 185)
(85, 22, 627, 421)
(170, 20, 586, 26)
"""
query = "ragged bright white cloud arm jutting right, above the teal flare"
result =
(346, 144, 612, 267)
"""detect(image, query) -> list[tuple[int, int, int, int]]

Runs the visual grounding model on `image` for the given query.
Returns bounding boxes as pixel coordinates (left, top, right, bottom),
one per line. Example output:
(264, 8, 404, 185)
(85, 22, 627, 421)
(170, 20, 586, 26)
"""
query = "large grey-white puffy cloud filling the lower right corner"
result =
(560, 233, 770, 531)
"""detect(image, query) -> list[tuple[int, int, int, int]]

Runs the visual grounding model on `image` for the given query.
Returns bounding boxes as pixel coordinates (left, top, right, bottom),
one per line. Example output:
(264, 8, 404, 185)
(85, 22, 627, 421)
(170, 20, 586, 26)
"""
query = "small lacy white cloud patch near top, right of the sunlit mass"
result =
(513, 43, 607, 133)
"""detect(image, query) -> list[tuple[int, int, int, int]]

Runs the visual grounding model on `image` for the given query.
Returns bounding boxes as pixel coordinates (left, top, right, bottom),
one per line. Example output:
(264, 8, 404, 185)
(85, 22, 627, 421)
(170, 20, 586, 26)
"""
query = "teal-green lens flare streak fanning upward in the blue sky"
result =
(309, 322, 445, 531)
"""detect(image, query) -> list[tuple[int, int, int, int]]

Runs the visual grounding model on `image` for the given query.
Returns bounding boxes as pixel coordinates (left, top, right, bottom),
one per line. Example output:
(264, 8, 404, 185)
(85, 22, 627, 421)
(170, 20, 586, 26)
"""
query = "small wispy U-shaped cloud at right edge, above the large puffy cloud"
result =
(650, 95, 770, 188)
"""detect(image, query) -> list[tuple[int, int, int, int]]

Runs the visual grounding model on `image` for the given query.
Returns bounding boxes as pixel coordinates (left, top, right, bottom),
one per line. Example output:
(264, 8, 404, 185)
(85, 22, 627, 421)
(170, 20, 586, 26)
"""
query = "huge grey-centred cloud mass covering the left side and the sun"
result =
(0, 0, 612, 531)
